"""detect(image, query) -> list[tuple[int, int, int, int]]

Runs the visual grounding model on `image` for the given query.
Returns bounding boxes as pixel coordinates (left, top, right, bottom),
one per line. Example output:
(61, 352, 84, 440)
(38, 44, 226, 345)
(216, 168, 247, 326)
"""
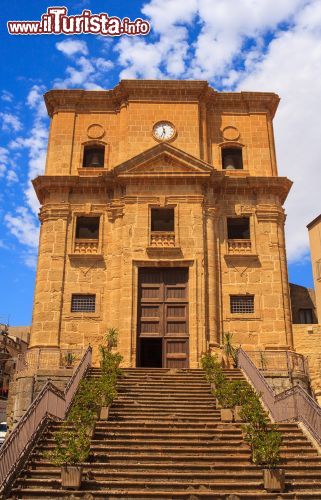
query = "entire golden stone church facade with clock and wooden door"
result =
(30, 80, 293, 368)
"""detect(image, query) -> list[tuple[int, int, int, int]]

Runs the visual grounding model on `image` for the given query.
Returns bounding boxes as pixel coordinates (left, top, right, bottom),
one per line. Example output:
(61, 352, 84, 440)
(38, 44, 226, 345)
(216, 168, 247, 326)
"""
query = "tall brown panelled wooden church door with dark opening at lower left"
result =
(137, 267, 189, 368)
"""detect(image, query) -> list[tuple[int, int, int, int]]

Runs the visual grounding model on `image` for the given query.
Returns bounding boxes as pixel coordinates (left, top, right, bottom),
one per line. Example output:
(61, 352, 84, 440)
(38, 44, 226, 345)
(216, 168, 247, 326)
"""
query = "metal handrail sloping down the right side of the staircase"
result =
(237, 348, 321, 445)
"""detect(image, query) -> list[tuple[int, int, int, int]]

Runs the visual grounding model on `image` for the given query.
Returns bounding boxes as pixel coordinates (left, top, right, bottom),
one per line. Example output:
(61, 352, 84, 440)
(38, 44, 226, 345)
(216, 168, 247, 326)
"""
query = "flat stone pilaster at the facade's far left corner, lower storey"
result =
(30, 207, 69, 354)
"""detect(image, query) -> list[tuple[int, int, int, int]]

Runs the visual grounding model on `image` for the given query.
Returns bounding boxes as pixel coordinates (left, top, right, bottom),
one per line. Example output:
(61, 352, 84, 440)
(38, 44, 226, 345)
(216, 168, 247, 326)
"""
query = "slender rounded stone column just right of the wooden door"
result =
(206, 206, 220, 349)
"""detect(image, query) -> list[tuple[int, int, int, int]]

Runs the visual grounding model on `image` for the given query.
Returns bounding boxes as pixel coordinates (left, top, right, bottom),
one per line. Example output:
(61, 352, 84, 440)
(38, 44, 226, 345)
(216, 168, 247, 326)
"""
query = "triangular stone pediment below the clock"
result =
(114, 144, 213, 177)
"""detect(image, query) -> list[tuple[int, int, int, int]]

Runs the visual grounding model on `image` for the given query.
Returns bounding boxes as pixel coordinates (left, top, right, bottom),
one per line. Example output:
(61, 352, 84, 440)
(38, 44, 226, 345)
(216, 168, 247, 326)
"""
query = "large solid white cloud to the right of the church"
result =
(232, 2, 321, 261)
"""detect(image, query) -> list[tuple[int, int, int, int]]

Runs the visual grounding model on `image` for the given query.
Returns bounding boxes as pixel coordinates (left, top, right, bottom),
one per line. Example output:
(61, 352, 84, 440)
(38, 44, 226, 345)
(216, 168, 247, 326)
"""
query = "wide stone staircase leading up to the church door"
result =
(9, 368, 321, 500)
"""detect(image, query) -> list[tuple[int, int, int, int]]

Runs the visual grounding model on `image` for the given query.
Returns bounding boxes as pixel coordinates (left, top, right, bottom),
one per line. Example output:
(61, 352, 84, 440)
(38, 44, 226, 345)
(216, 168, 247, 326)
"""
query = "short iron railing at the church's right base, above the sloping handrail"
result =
(247, 349, 308, 376)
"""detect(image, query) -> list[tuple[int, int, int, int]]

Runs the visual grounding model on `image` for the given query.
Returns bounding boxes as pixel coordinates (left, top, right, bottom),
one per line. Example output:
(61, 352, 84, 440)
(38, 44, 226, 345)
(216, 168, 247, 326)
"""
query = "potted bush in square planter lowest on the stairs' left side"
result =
(47, 425, 90, 490)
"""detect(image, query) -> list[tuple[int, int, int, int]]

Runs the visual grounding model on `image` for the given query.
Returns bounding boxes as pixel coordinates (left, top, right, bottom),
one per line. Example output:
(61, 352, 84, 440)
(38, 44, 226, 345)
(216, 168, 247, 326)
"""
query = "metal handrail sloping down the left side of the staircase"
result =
(0, 347, 92, 491)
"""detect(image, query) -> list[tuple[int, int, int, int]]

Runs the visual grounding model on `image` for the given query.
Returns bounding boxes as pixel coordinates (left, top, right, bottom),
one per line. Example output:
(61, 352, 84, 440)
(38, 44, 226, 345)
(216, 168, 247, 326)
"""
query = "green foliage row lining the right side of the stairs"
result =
(201, 348, 282, 468)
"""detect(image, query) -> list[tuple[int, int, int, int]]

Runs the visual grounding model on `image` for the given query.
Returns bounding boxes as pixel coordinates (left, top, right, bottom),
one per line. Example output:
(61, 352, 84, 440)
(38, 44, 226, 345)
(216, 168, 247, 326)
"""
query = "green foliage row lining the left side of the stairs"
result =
(46, 328, 122, 466)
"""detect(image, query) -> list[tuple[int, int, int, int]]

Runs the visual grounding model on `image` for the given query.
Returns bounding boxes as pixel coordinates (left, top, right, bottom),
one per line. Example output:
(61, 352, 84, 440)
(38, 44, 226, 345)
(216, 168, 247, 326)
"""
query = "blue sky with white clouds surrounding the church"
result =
(0, 0, 321, 325)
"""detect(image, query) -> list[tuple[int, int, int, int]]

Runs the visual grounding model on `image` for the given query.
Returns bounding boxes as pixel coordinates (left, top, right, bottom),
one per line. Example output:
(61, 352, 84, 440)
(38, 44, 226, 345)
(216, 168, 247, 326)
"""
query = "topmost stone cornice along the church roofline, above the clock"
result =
(44, 80, 280, 117)
